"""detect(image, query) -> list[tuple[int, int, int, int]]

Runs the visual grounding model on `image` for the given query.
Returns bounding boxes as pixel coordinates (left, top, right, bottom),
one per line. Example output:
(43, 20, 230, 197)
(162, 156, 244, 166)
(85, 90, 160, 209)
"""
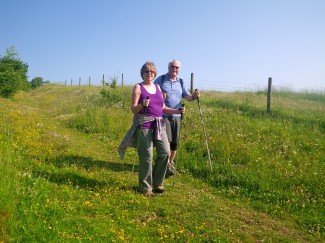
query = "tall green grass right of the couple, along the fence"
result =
(180, 90, 325, 234)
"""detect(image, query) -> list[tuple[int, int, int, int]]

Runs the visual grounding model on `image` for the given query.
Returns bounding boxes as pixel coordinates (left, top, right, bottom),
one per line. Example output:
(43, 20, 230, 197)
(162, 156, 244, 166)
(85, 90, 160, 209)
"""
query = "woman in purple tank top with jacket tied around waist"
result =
(119, 62, 185, 197)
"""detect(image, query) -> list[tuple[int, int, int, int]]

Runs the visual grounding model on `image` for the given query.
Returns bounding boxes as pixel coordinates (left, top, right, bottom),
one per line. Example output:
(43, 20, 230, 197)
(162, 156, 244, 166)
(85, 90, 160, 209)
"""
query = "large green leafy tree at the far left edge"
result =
(0, 46, 30, 98)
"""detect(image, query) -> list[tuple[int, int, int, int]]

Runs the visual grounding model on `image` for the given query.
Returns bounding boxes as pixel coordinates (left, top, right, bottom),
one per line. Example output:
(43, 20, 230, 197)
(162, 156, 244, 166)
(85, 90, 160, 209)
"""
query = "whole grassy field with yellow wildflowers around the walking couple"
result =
(0, 85, 325, 242)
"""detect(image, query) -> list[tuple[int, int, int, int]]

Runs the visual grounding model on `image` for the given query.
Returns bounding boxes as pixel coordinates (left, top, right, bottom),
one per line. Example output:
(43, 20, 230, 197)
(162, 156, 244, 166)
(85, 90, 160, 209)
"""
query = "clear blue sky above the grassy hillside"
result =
(0, 0, 325, 90)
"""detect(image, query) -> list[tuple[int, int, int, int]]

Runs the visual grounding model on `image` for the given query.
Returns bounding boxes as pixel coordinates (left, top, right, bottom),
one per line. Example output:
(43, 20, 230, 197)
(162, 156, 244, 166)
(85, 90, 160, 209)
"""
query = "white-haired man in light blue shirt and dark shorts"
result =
(154, 60, 200, 177)
